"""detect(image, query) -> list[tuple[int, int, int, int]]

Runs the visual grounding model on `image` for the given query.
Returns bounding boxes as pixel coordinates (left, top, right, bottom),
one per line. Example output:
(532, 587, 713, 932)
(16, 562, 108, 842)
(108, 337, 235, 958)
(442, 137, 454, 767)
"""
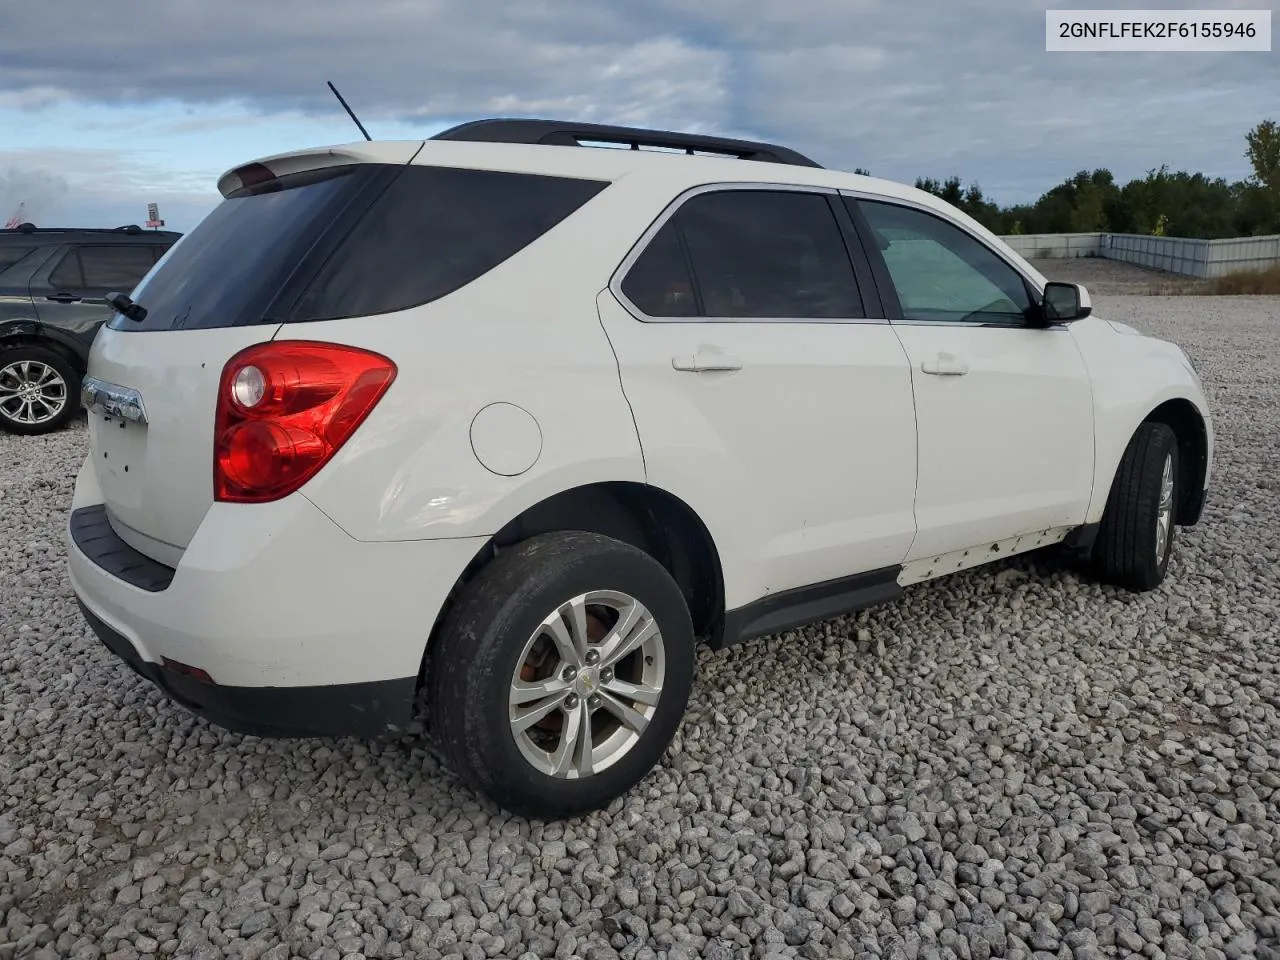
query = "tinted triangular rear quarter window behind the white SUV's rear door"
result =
(291, 166, 607, 320)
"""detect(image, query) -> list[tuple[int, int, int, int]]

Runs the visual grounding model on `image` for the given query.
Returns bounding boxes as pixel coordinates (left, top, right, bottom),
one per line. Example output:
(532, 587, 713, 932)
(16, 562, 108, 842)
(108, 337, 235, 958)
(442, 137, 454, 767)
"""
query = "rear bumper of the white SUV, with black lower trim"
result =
(67, 455, 485, 733)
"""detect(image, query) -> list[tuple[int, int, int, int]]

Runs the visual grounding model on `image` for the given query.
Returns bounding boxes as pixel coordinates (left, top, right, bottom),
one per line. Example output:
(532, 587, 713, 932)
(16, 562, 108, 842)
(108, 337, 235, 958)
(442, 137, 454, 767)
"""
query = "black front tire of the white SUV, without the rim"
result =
(1093, 424, 1180, 593)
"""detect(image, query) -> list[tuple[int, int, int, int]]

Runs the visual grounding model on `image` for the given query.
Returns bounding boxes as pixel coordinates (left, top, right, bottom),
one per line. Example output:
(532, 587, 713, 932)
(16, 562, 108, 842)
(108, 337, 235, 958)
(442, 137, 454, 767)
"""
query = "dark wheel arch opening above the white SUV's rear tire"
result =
(419, 481, 724, 685)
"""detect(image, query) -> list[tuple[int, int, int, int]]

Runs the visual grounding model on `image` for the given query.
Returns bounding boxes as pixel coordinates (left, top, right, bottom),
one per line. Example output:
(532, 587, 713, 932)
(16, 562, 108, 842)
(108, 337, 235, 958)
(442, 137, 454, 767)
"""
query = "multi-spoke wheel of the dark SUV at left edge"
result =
(0, 344, 81, 434)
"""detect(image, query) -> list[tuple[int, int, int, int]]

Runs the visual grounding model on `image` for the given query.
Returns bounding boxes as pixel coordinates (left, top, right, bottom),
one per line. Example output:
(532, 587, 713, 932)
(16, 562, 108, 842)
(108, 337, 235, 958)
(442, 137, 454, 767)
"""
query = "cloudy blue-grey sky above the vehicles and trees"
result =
(0, 0, 1280, 230)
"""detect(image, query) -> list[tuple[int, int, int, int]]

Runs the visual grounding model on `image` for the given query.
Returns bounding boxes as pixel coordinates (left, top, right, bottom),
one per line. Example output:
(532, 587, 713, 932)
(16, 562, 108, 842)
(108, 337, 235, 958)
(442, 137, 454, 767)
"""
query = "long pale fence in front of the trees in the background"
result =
(1001, 233, 1280, 278)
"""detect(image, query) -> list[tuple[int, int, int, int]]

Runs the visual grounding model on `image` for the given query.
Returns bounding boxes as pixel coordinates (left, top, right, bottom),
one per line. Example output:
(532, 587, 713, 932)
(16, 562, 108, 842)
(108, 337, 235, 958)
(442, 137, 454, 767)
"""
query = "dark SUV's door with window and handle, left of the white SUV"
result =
(31, 243, 165, 343)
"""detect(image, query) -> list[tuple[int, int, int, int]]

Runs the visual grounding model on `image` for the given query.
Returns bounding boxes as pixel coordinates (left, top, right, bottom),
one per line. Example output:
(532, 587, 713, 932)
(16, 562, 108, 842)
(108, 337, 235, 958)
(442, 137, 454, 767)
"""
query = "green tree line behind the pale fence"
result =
(915, 120, 1280, 239)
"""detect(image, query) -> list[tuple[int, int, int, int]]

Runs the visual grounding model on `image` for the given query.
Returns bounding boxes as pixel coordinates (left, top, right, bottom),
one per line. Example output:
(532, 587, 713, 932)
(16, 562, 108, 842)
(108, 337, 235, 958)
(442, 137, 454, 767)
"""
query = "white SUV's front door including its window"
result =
(846, 198, 1093, 561)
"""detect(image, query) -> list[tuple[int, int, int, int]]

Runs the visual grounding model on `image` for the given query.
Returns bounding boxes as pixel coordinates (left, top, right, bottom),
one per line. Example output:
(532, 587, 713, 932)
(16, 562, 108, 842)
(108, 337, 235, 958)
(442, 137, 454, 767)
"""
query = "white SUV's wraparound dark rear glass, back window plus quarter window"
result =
(111, 164, 607, 330)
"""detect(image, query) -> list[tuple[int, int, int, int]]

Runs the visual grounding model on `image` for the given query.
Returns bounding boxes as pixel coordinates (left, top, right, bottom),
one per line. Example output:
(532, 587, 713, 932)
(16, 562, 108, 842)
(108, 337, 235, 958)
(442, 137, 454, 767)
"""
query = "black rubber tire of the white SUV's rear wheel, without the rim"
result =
(428, 532, 694, 819)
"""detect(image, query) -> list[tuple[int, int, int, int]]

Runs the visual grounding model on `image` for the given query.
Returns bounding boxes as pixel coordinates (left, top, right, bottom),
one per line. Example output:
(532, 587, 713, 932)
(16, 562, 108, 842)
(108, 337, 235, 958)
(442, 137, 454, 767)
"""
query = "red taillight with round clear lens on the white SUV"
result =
(214, 340, 396, 503)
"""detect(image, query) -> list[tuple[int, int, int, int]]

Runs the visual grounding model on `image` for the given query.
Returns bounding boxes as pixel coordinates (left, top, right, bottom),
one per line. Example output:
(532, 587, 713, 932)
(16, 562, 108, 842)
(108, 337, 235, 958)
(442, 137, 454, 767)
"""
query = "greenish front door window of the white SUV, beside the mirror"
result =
(846, 200, 1033, 325)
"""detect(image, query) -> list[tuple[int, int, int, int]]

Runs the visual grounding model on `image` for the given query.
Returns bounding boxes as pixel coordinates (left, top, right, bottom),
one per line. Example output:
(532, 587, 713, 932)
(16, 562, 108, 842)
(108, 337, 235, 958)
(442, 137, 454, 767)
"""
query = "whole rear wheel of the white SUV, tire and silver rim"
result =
(429, 532, 694, 819)
